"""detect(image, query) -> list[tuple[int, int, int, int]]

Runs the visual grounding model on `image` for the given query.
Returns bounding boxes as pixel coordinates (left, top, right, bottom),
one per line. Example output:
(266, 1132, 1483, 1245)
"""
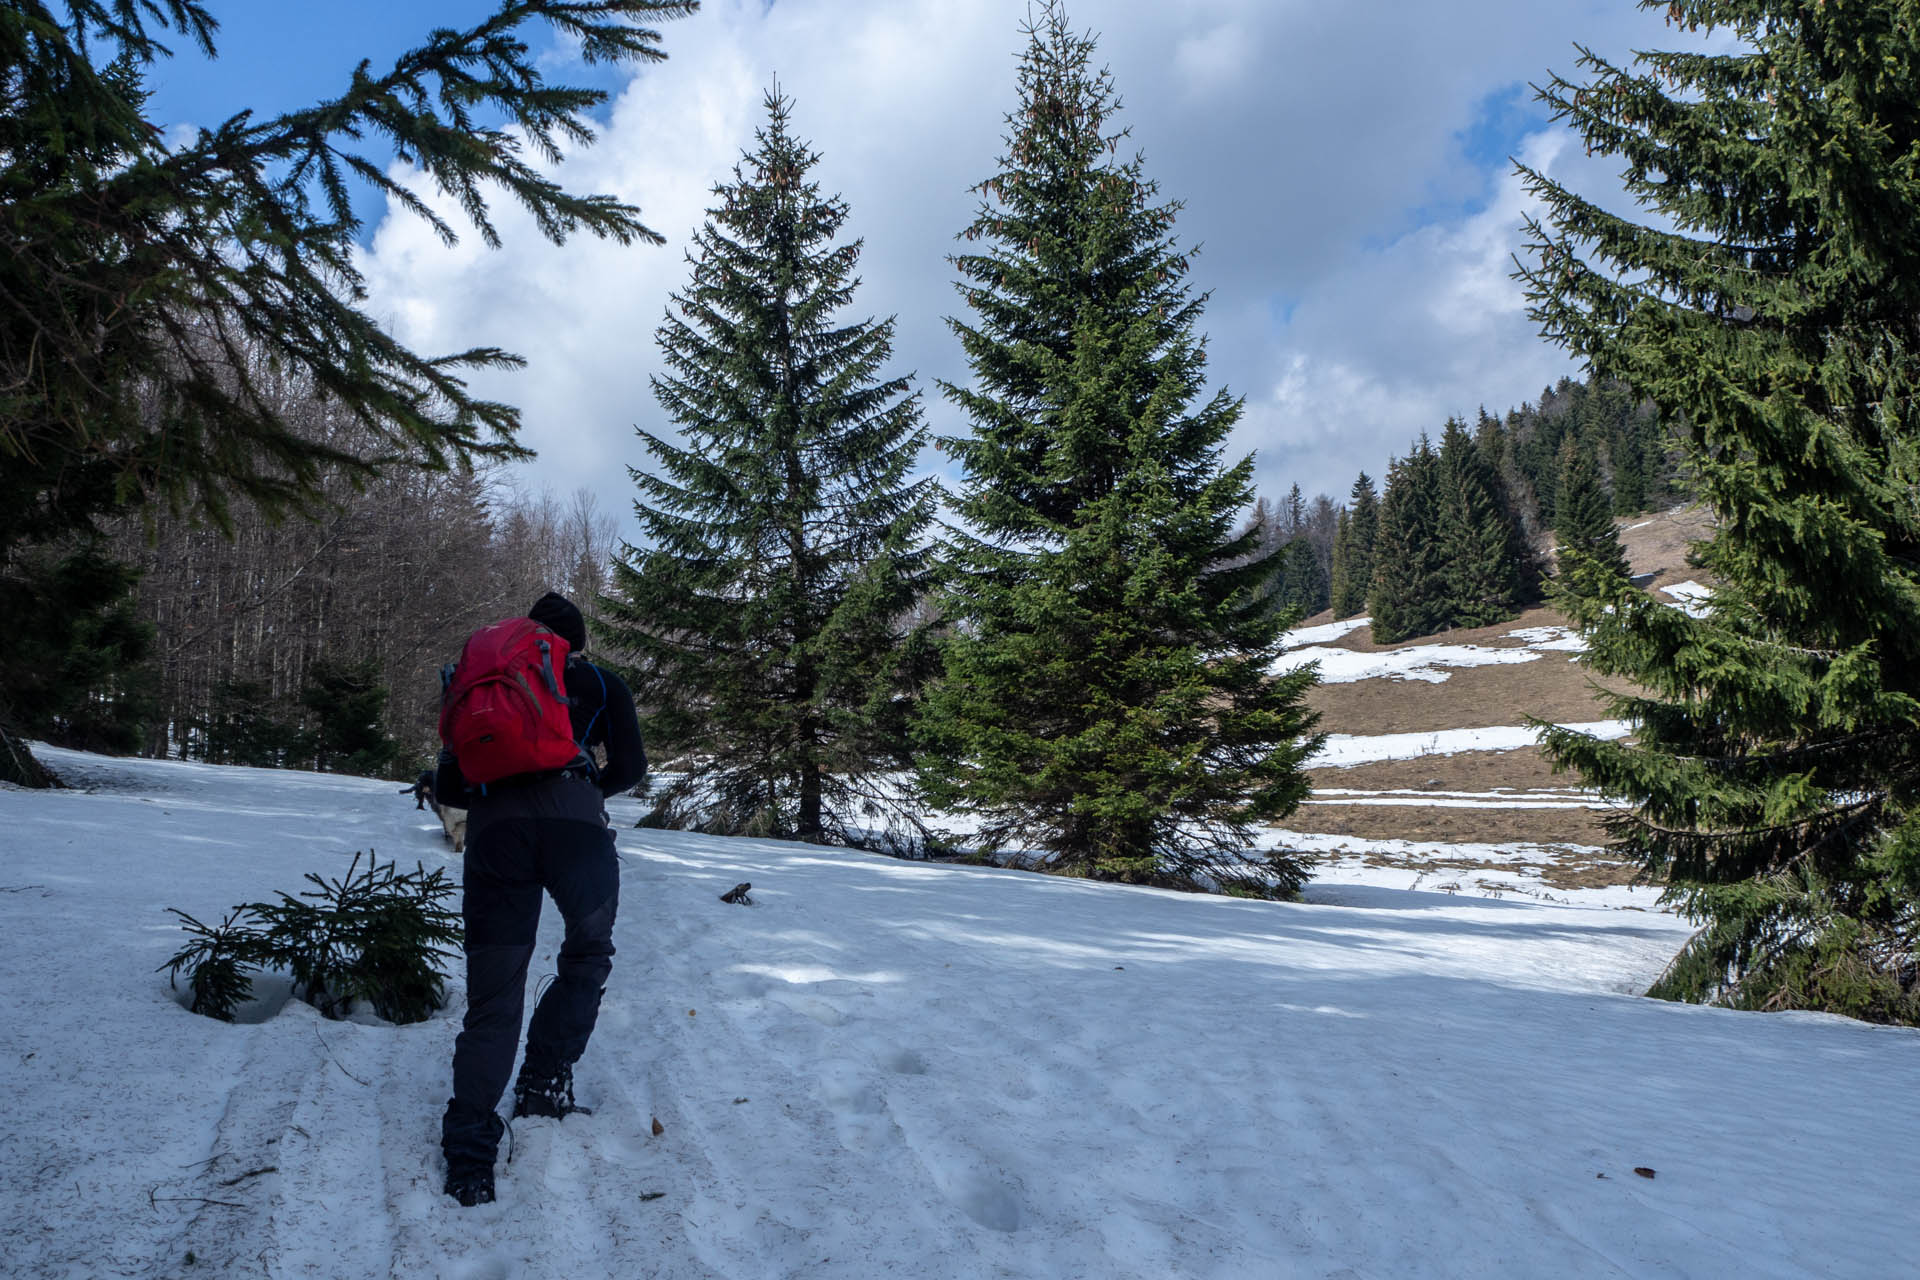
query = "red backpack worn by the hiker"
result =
(440, 618, 582, 783)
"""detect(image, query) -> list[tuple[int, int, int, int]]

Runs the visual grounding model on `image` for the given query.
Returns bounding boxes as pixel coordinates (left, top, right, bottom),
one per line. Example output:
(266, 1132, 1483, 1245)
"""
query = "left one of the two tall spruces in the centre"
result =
(601, 90, 935, 842)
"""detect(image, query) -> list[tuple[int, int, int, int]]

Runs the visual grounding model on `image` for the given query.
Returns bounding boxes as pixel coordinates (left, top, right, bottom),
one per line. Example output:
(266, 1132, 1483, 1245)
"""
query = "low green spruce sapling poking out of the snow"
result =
(161, 854, 463, 1023)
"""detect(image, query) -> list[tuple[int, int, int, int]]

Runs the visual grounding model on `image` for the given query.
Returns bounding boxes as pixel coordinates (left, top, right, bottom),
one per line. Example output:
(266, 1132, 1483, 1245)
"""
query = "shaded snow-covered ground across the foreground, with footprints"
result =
(0, 752, 1920, 1280)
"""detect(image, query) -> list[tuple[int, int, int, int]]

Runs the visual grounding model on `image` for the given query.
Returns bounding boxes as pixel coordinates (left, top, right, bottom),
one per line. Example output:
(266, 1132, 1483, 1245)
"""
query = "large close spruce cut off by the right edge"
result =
(1523, 0, 1920, 1021)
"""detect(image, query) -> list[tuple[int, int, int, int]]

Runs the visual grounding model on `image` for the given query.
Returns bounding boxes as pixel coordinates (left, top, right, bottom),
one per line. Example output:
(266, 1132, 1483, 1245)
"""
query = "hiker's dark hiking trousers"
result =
(440, 777, 620, 1169)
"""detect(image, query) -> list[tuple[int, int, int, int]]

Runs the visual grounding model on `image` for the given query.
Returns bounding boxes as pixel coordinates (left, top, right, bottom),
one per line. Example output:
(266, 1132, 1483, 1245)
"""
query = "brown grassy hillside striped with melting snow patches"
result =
(1281, 509, 1707, 896)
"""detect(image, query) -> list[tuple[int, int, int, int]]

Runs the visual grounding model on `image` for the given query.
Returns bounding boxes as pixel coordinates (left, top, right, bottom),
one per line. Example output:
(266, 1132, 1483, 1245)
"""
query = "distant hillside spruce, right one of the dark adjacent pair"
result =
(1436, 418, 1524, 628)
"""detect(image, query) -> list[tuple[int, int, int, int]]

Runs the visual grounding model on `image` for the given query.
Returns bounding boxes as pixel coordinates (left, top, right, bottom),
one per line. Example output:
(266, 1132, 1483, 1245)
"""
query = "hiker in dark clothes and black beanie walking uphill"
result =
(434, 591, 647, 1205)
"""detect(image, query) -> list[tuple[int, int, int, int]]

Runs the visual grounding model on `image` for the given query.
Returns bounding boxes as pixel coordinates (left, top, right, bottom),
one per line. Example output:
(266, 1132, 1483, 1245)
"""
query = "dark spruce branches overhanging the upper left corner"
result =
(0, 0, 691, 782)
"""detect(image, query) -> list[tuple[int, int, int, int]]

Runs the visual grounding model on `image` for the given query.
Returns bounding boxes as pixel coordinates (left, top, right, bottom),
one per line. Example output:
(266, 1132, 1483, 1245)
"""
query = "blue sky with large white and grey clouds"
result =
(152, 0, 1680, 537)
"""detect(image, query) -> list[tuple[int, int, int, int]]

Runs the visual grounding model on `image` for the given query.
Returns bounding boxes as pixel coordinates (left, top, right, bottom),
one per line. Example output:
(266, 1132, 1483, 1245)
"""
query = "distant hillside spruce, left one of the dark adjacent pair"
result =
(1367, 436, 1448, 645)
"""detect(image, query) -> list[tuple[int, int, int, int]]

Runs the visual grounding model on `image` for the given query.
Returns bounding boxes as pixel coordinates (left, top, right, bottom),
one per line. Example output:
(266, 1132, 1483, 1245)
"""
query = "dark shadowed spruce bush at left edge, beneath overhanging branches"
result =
(0, 539, 154, 754)
